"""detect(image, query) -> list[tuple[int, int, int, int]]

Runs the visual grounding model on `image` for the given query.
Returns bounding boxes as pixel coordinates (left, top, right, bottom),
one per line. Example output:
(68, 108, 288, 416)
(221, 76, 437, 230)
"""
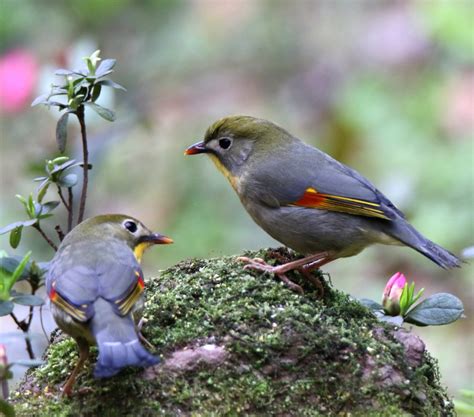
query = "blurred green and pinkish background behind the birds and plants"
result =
(0, 0, 474, 395)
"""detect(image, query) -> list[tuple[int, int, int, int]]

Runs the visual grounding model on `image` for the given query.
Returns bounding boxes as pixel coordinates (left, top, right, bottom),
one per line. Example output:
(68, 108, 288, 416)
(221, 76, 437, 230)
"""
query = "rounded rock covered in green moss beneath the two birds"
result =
(12, 249, 454, 417)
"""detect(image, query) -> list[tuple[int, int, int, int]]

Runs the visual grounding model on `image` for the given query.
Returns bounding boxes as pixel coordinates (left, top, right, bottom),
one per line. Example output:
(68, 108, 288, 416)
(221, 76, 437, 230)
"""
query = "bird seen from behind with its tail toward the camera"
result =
(46, 214, 173, 396)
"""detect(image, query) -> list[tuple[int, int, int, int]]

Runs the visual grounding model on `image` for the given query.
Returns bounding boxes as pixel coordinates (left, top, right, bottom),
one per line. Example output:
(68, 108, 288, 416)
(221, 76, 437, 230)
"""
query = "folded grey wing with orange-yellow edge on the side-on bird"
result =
(246, 142, 403, 220)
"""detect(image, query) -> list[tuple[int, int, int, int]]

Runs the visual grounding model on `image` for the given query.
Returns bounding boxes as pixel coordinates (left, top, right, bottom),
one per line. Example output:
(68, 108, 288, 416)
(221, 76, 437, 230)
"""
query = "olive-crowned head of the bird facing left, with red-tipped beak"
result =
(184, 116, 295, 180)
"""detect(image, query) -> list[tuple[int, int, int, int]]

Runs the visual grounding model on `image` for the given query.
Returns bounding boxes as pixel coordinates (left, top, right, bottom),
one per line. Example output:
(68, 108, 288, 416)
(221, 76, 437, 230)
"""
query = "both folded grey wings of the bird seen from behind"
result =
(46, 240, 145, 322)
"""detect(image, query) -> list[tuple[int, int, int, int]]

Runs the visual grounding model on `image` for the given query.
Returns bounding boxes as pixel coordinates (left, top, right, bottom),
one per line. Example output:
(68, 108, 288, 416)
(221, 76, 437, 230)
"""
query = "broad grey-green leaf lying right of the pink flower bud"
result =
(405, 293, 464, 326)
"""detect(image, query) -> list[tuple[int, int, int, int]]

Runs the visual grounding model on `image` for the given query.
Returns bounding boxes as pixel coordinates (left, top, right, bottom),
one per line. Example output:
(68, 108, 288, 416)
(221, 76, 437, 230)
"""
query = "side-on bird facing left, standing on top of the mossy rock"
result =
(185, 116, 461, 290)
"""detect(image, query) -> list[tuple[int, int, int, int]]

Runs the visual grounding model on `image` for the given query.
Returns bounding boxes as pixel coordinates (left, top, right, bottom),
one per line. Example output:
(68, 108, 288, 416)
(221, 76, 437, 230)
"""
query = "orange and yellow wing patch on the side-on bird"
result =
(292, 187, 390, 220)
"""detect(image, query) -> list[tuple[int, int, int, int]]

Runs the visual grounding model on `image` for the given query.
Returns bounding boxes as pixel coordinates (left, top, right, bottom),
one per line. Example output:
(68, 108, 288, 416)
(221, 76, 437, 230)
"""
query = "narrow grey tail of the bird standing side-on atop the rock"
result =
(390, 220, 463, 269)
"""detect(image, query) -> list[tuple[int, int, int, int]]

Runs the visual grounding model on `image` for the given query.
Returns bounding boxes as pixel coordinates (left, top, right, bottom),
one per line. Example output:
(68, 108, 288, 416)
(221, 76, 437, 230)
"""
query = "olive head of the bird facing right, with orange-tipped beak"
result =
(63, 214, 173, 260)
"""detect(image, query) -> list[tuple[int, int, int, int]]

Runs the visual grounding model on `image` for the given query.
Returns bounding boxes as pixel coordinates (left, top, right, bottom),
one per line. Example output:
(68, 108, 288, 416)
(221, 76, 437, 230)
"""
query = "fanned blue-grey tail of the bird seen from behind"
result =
(92, 299, 159, 378)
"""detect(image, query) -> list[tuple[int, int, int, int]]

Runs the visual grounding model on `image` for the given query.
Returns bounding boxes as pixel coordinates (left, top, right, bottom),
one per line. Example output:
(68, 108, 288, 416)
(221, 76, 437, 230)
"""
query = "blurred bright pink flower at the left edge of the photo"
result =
(0, 49, 38, 113)
